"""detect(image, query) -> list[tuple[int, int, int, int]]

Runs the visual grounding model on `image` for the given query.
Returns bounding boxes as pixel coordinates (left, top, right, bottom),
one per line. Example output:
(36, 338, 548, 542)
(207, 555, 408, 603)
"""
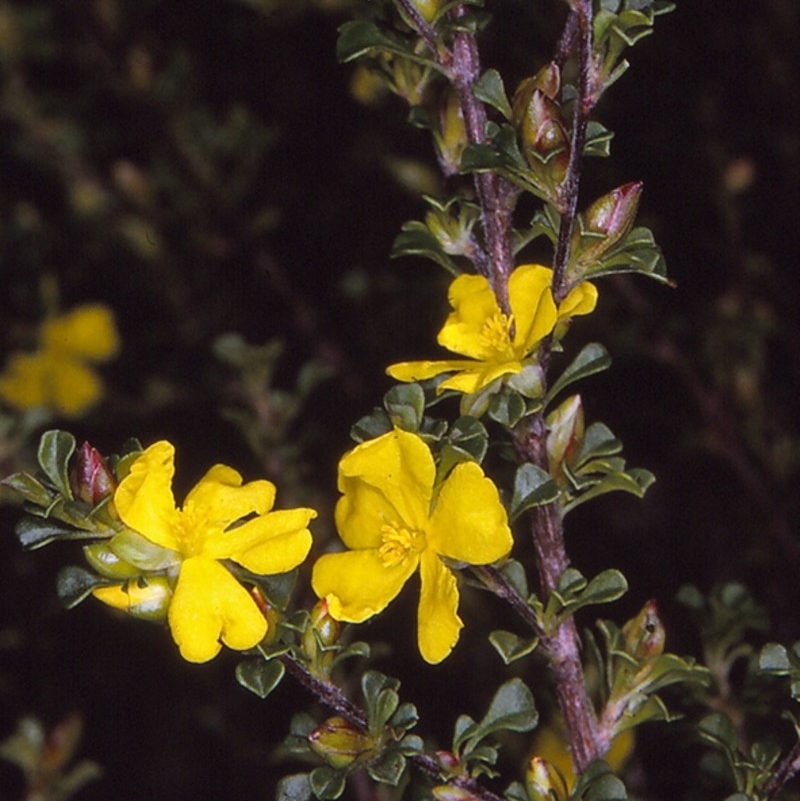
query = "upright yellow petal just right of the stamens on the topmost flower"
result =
(508, 264, 556, 357)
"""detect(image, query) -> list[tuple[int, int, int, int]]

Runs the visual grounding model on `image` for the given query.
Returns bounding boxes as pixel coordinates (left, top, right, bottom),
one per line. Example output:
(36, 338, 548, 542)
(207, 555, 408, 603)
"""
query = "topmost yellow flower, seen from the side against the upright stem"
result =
(386, 264, 597, 394)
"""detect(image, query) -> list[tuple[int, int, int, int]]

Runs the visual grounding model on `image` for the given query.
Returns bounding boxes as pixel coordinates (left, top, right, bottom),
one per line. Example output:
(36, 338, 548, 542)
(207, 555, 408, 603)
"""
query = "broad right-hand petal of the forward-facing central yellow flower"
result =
(427, 462, 514, 565)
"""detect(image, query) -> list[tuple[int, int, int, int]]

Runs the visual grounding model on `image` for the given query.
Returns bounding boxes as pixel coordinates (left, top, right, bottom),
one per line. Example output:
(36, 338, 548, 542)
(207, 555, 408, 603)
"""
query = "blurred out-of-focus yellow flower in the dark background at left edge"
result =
(0, 304, 119, 417)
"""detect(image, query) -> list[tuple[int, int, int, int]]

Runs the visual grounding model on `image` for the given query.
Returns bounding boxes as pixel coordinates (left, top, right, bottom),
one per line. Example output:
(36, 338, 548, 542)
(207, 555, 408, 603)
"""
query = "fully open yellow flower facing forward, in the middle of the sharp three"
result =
(311, 430, 513, 663)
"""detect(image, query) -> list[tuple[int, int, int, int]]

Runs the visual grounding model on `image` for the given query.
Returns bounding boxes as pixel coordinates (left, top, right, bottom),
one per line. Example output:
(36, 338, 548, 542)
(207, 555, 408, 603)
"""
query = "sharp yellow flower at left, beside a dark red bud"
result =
(108, 441, 316, 662)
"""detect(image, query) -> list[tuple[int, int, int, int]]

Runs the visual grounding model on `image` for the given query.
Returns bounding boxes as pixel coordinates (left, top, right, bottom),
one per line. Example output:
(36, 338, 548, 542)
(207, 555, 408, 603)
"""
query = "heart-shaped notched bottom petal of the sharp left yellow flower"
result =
(169, 556, 267, 662)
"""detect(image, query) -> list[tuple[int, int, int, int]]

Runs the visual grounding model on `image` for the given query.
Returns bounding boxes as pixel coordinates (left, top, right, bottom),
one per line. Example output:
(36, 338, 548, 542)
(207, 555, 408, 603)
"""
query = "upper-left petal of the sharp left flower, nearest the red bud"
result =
(114, 440, 179, 550)
